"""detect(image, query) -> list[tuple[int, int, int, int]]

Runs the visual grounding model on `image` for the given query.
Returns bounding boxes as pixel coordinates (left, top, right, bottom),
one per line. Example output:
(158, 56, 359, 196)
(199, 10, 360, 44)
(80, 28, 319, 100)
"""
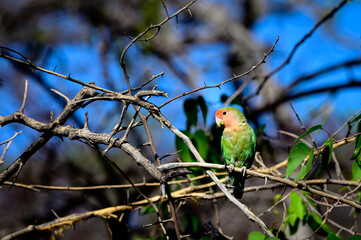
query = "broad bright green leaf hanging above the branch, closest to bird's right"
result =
(286, 142, 309, 178)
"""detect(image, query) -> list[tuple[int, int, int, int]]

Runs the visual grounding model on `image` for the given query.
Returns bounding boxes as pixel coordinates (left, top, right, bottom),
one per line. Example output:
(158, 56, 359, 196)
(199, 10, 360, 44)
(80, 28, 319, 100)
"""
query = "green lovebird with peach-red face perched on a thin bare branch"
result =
(216, 107, 256, 199)
